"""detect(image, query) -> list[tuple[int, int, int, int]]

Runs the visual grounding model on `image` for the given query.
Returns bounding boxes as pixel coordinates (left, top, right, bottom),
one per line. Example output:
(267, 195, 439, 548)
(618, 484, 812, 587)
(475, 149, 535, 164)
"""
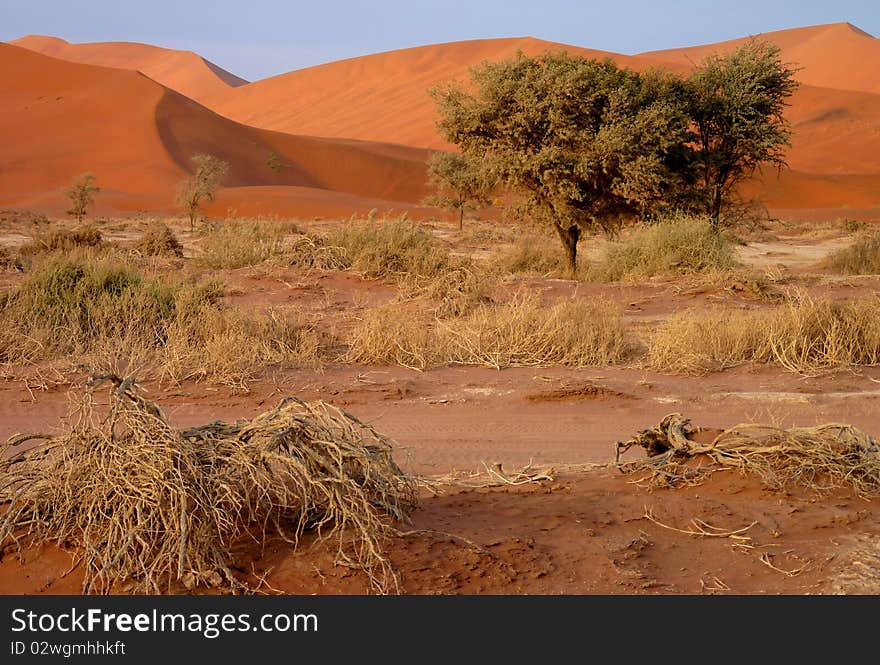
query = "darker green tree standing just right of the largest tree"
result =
(688, 40, 798, 228)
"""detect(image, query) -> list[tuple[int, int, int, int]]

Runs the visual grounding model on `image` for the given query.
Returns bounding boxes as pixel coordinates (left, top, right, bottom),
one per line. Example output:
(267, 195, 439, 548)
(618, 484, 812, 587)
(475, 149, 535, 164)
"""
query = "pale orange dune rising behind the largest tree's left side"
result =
(208, 37, 688, 148)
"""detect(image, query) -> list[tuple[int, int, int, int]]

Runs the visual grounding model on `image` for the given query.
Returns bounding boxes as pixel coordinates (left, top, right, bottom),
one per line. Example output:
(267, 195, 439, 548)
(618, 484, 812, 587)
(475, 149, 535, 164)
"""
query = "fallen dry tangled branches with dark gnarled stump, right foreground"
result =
(616, 413, 880, 497)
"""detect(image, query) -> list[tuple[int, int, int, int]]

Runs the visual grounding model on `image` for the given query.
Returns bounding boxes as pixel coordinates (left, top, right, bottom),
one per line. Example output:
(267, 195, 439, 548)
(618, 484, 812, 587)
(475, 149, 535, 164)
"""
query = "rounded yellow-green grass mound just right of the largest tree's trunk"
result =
(590, 216, 736, 281)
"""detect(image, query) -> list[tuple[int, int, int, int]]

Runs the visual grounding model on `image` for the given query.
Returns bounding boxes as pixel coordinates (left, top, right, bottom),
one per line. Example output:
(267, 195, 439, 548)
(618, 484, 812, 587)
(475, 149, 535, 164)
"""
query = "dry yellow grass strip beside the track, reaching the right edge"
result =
(647, 294, 880, 374)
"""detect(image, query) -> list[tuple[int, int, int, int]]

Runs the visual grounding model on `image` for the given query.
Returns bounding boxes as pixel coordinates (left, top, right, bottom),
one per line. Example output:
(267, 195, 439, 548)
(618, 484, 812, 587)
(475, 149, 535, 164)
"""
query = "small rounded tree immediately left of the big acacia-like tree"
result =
(424, 152, 492, 231)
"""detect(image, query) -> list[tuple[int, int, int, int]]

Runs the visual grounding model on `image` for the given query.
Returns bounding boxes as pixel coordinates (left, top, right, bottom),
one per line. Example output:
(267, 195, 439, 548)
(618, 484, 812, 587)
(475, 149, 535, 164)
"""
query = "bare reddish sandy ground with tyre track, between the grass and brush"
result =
(0, 219, 880, 594)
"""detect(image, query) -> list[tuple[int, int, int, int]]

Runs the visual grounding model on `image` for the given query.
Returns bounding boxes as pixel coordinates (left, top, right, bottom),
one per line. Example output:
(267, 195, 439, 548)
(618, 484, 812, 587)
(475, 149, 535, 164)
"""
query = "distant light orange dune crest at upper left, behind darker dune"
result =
(10, 35, 247, 104)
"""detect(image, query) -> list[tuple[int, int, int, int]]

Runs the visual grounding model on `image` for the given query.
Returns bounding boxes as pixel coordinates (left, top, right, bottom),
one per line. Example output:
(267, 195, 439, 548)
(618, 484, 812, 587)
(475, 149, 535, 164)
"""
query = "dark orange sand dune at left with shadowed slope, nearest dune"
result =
(0, 44, 426, 219)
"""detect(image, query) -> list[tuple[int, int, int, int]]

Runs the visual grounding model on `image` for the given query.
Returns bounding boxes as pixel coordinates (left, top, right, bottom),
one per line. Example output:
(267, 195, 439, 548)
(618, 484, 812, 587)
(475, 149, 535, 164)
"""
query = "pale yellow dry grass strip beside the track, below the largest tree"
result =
(345, 297, 628, 369)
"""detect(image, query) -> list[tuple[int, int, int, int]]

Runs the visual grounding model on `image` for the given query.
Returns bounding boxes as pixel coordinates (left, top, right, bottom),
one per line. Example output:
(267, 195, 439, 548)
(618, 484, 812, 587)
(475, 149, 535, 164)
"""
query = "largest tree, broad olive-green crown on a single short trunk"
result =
(431, 53, 688, 272)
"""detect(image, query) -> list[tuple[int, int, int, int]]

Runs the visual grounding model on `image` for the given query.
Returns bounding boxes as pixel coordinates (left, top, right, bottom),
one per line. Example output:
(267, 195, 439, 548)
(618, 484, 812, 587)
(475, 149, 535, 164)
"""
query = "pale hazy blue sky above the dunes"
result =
(0, 0, 880, 80)
